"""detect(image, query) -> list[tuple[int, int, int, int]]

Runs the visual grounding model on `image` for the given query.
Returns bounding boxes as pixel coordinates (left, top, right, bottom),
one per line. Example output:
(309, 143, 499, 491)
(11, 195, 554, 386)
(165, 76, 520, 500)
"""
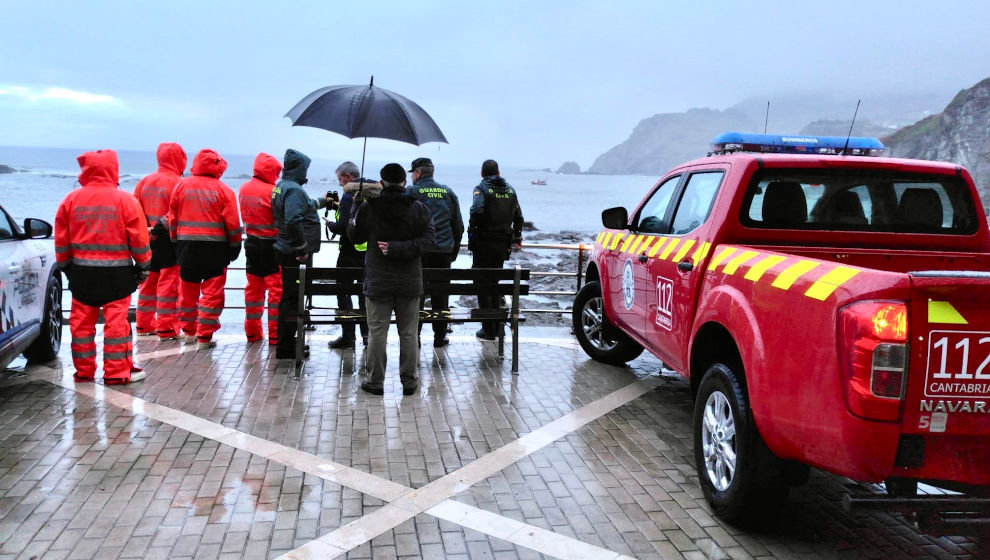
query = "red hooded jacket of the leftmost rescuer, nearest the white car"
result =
(55, 150, 151, 270)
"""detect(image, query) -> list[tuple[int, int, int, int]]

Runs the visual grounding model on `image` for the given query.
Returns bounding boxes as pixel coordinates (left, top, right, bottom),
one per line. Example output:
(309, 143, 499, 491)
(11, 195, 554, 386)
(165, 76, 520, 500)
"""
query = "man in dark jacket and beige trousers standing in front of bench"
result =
(347, 163, 435, 395)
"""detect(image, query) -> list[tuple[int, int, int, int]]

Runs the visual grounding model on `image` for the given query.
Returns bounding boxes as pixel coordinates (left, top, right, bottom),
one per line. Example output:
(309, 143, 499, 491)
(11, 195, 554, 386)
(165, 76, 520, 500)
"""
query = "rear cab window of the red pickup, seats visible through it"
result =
(740, 169, 979, 235)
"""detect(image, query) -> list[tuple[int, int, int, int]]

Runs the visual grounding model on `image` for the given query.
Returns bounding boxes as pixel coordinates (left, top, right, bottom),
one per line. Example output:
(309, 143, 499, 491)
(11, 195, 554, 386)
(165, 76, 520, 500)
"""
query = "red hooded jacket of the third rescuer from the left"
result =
(168, 149, 241, 246)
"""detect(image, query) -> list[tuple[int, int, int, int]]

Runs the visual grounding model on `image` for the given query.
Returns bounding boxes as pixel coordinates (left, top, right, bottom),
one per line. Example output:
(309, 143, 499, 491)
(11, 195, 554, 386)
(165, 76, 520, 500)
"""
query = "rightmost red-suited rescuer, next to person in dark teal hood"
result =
(238, 153, 282, 346)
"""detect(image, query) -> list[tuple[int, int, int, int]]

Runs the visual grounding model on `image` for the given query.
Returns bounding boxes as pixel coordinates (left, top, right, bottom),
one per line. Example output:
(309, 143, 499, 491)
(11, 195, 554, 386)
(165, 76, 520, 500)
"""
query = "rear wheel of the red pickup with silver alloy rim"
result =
(694, 363, 788, 527)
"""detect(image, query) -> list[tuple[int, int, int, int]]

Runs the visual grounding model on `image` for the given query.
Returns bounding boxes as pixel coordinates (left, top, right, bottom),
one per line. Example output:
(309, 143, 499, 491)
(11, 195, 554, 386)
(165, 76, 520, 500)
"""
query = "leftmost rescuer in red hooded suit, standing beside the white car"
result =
(55, 150, 151, 385)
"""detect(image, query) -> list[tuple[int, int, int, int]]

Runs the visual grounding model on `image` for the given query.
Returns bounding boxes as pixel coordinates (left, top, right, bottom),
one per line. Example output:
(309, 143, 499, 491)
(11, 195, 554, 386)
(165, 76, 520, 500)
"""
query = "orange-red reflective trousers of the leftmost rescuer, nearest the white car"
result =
(69, 295, 134, 384)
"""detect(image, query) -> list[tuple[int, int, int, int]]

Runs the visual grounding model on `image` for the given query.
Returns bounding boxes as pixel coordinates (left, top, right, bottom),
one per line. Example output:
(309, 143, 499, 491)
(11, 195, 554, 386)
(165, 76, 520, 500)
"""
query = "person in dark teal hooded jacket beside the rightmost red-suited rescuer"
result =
(272, 149, 328, 359)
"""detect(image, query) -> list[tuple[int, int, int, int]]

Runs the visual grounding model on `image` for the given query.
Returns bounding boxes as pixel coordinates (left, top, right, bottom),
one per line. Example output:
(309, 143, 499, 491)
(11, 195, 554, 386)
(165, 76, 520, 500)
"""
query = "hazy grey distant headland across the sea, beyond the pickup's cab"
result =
(588, 109, 756, 175)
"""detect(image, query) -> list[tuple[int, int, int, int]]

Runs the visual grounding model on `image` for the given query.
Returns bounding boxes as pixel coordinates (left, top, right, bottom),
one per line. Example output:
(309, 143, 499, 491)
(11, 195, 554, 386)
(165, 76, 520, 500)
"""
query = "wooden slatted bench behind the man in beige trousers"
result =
(282, 265, 529, 377)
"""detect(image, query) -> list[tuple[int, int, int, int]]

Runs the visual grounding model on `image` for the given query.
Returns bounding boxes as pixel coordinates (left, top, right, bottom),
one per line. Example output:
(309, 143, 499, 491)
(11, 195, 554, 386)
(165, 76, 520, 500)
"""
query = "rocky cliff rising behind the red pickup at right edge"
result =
(882, 78, 990, 215)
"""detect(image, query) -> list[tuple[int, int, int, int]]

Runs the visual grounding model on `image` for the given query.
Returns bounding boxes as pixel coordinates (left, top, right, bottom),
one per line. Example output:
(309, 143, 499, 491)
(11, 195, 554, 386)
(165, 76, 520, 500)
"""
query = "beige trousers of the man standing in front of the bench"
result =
(364, 296, 419, 388)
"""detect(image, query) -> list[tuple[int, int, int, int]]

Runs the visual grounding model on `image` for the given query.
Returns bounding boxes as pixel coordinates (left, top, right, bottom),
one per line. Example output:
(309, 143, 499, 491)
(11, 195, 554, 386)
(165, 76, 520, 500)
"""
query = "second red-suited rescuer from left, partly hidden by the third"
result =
(134, 142, 186, 340)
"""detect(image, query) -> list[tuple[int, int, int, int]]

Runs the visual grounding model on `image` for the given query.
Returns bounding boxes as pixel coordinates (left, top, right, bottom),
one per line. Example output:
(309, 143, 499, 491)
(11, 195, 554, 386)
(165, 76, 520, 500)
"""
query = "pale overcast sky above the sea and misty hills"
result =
(0, 0, 990, 168)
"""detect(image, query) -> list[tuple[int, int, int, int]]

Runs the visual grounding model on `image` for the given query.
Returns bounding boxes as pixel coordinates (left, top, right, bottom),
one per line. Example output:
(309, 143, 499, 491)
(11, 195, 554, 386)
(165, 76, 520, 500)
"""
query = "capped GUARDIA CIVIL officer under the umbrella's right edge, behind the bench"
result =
(406, 154, 464, 348)
